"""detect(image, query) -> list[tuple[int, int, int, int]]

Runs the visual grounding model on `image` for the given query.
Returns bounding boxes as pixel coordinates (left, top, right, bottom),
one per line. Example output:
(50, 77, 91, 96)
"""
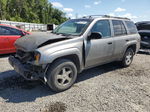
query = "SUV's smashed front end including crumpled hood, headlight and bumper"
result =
(9, 34, 69, 82)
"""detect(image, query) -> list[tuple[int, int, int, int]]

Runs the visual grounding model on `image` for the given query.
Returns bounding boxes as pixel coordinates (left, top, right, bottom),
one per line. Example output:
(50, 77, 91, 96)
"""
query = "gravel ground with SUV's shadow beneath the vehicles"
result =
(0, 53, 150, 112)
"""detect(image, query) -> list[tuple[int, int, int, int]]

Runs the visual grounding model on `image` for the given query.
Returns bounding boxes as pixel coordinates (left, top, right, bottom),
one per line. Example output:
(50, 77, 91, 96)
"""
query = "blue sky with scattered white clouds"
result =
(49, 0, 150, 22)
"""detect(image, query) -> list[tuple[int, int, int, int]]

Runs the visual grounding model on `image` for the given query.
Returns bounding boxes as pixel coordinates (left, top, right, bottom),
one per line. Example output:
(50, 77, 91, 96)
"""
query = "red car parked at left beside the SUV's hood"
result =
(0, 24, 30, 54)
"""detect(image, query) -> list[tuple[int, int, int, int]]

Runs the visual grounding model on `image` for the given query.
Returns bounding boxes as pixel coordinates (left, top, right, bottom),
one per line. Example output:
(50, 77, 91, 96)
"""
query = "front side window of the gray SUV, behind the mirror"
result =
(91, 20, 111, 37)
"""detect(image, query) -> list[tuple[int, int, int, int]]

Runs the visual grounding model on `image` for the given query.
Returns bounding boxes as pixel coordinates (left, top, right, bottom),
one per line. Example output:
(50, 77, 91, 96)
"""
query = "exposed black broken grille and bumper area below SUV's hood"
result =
(9, 50, 45, 80)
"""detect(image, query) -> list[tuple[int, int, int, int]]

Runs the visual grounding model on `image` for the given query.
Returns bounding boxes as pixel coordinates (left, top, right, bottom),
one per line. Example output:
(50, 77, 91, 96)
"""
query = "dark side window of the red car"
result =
(0, 26, 22, 35)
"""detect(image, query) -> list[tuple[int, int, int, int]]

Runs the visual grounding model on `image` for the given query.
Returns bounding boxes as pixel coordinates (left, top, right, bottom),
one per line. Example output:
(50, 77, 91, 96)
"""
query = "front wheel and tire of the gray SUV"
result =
(47, 59, 77, 92)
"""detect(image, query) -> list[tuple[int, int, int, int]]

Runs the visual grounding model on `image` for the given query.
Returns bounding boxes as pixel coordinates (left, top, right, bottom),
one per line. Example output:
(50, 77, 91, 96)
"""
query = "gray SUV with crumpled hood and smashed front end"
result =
(9, 15, 140, 92)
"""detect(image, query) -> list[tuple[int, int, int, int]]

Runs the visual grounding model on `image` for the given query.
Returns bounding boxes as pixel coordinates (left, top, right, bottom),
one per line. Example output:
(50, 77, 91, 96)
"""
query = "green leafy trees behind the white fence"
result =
(0, 0, 67, 24)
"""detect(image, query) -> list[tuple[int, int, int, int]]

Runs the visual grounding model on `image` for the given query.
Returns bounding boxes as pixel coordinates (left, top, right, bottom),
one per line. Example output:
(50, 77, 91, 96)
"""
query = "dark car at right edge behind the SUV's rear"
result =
(136, 21, 150, 49)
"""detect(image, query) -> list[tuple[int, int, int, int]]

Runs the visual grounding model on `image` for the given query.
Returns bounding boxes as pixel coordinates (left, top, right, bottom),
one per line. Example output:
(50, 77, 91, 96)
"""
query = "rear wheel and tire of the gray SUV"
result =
(121, 48, 134, 67)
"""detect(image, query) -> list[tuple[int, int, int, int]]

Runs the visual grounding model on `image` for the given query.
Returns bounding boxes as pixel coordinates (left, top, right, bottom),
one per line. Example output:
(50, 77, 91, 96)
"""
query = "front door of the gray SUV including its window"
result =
(85, 20, 114, 68)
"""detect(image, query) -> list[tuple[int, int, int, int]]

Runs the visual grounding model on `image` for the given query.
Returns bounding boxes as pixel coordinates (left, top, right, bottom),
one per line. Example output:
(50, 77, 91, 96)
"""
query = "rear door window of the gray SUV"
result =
(112, 20, 127, 36)
